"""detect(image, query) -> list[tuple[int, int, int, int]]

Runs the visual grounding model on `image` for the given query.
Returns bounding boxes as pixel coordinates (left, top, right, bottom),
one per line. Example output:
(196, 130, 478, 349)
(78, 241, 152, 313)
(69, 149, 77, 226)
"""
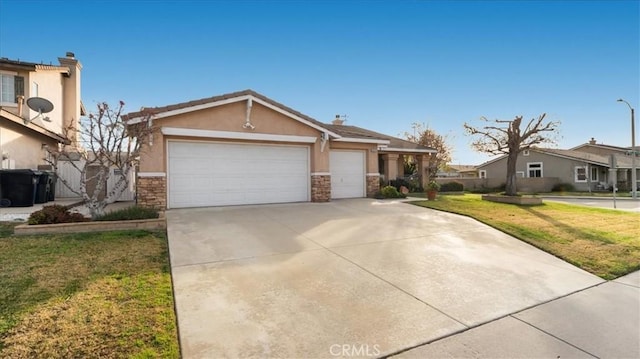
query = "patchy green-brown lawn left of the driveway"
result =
(0, 223, 179, 358)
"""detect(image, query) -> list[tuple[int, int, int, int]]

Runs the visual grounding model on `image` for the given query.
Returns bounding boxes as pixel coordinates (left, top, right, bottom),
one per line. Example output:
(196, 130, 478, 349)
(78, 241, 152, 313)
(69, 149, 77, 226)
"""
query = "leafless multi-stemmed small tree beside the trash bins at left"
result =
(48, 101, 151, 218)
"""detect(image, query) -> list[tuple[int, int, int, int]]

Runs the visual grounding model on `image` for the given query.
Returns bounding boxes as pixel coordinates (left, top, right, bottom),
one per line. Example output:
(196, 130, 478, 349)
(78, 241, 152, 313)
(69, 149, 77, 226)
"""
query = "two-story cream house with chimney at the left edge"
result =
(0, 53, 82, 169)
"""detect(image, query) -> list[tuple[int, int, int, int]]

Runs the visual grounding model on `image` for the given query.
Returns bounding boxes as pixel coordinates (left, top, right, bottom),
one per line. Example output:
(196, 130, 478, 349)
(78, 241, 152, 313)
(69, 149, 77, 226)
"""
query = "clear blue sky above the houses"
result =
(0, 0, 640, 164)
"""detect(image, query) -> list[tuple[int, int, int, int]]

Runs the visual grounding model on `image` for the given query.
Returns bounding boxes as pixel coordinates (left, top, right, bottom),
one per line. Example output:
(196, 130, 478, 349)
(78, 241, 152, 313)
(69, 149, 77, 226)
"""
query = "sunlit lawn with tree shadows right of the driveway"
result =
(413, 194, 640, 279)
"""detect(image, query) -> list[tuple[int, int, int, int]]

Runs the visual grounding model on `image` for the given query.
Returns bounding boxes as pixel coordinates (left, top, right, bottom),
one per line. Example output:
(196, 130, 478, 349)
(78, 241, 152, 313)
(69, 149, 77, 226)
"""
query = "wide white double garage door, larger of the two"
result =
(168, 141, 310, 208)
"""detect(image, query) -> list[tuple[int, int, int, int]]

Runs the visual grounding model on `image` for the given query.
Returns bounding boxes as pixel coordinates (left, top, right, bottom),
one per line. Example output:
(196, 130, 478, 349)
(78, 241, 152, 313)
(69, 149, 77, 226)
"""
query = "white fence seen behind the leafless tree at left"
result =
(56, 159, 136, 201)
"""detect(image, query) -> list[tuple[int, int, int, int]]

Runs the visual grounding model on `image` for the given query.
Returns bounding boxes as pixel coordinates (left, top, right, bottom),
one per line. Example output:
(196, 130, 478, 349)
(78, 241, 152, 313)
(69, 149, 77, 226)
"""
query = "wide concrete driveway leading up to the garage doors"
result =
(167, 199, 603, 358)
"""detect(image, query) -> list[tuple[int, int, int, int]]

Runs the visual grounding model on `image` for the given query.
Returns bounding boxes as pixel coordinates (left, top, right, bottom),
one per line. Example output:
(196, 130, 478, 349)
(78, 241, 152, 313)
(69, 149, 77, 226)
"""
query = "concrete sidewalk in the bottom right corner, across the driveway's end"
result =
(396, 271, 640, 358)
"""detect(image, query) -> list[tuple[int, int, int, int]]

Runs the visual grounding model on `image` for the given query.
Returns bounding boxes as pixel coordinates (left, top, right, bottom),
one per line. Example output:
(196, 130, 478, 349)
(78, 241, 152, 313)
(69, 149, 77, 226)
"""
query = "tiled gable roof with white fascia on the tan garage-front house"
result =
(122, 89, 436, 153)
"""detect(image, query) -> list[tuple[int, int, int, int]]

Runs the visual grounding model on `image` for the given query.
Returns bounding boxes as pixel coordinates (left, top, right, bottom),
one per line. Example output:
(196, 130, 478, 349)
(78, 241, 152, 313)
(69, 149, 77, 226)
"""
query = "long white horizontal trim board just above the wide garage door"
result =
(162, 127, 318, 143)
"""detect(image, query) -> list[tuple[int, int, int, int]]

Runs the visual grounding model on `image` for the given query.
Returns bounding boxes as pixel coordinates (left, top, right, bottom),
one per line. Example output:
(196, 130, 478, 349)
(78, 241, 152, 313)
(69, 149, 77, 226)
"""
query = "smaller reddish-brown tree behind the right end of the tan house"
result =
(404, 122, 452, 180)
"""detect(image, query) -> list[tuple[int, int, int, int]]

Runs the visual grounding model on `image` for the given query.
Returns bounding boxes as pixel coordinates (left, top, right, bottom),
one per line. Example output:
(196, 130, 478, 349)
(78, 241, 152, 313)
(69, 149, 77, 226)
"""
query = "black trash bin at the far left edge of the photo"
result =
(0, 170, 40, 207)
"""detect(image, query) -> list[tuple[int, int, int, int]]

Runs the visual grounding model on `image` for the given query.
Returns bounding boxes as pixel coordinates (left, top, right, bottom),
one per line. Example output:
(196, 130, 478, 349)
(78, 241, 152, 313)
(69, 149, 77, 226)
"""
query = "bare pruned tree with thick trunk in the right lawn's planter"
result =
(464, 113, 560, 196)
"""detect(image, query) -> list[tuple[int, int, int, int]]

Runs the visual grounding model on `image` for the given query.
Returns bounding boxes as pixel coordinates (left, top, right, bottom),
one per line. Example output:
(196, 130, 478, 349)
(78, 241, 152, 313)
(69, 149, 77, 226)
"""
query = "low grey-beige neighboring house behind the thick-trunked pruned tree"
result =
(478, 146, 631, 191)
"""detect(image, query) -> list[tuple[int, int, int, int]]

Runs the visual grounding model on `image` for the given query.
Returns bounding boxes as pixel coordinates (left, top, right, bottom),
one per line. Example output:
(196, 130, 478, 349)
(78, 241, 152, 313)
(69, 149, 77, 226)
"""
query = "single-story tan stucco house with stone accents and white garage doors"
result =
(123, 90, 435, 208)
